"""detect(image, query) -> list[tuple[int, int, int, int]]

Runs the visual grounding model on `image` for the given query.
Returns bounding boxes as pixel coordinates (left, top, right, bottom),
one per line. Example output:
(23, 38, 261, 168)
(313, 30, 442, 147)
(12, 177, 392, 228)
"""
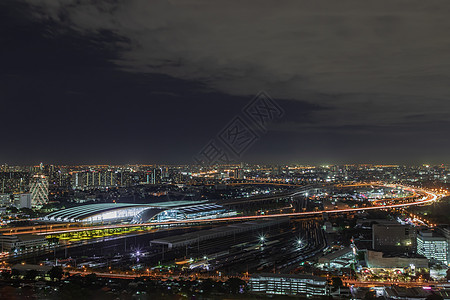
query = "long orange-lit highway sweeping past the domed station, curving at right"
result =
(20, 185, 439, 235)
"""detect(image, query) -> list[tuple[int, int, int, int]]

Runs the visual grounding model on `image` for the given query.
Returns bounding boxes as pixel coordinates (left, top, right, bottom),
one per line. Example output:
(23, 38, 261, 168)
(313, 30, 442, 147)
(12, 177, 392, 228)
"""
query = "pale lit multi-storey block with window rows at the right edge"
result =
(417, 230, 448, 265)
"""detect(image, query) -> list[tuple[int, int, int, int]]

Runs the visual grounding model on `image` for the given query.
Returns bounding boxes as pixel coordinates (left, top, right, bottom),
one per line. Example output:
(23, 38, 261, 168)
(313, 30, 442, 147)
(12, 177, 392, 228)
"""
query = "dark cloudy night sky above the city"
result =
(0, 0, 450, 164)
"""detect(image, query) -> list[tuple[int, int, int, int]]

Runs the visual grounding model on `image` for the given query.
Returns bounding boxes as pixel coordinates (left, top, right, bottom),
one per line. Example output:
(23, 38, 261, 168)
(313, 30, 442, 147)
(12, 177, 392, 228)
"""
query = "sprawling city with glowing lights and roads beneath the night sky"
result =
(0, 163, 450, 299)
